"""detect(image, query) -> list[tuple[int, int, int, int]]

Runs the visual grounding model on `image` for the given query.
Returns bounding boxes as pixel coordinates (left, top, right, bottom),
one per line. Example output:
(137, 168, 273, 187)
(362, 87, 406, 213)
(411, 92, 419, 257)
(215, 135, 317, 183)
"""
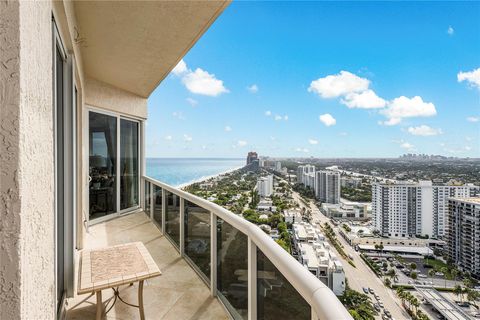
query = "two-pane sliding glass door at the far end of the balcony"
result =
(88, 111, 140, 220)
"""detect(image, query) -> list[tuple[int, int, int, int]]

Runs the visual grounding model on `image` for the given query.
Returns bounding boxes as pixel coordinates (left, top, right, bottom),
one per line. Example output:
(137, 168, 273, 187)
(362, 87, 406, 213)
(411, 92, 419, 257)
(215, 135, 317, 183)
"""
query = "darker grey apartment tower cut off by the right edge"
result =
(446, 197, 480, 279)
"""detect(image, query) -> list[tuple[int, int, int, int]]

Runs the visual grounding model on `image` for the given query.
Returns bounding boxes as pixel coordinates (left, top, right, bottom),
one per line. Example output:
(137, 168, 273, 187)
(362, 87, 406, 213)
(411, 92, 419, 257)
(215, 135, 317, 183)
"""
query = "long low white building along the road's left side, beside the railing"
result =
(293, 222, 345, 295)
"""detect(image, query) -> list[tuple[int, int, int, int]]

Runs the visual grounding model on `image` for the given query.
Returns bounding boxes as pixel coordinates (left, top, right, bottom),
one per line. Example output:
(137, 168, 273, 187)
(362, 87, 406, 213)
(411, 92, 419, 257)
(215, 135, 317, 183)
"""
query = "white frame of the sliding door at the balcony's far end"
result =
(84, 105, 145, 226)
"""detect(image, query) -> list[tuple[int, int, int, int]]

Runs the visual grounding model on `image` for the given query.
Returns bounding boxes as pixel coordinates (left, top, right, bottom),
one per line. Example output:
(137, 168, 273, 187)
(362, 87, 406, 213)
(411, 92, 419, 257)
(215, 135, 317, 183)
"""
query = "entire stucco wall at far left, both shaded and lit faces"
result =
(0, 1, 56, 319)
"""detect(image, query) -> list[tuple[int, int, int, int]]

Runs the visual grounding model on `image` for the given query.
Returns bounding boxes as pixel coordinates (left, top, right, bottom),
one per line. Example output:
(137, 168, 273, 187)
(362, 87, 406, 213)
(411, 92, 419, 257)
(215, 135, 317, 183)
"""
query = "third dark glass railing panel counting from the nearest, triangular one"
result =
(184, 200, 210, 279)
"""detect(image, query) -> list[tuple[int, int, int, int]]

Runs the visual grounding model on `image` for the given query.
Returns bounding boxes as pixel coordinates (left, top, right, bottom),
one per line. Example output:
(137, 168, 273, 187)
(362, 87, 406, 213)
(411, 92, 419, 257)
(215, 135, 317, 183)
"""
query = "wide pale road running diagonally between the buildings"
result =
(292, 192, 410, 320)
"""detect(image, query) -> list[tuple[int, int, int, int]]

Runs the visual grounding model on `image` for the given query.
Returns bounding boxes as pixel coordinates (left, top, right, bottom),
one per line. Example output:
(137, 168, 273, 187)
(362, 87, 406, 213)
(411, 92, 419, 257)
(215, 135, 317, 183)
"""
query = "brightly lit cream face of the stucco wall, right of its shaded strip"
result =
(18, 1, 56, 319)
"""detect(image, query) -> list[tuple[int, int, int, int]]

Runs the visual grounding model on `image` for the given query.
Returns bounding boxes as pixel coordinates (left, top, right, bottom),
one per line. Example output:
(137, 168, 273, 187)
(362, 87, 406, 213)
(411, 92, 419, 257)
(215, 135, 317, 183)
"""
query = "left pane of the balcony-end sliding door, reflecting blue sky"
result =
(89, 112, 117, 220)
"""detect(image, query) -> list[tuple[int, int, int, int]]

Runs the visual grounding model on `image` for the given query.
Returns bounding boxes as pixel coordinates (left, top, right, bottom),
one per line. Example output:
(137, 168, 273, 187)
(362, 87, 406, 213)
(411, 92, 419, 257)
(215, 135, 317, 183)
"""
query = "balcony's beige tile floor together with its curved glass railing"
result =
(68, 177, 351, 320)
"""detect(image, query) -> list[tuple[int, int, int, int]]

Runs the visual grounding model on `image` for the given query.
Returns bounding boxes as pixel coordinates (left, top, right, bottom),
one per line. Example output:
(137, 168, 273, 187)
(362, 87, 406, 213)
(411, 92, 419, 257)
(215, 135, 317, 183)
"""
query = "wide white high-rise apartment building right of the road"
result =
(372, 181, 479, 238)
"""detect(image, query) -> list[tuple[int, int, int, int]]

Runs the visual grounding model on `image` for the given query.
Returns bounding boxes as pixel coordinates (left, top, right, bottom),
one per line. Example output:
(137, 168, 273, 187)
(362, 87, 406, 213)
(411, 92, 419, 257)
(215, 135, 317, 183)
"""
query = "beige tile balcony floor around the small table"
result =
(67, 212, 229, 320)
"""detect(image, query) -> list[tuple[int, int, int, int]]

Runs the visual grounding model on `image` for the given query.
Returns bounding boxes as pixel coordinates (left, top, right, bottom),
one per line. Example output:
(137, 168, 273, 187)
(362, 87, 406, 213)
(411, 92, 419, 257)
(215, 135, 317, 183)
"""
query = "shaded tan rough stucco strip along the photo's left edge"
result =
(0, 1, 21, 319)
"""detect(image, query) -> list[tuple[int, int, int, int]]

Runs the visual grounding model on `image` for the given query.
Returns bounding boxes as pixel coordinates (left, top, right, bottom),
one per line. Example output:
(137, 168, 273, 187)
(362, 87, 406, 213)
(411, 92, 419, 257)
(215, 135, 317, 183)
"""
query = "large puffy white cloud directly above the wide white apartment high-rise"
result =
(380, 96, 437, 126)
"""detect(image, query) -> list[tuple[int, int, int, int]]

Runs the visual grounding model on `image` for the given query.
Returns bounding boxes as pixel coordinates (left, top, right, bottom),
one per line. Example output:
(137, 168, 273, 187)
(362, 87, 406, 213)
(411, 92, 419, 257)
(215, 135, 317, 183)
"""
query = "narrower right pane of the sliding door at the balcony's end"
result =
(120, 119, 139, 210)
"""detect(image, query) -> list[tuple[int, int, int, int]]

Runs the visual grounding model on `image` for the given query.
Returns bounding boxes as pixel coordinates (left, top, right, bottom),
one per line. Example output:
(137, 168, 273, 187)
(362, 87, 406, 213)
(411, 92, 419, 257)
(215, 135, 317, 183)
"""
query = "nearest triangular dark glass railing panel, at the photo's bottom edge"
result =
(257, 249, 311, 320)
